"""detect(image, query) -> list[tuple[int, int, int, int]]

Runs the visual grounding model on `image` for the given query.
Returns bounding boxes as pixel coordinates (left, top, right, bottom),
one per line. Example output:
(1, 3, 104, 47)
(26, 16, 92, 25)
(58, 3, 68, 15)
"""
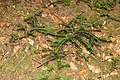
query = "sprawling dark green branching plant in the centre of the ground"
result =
(11, 8, 111, 67)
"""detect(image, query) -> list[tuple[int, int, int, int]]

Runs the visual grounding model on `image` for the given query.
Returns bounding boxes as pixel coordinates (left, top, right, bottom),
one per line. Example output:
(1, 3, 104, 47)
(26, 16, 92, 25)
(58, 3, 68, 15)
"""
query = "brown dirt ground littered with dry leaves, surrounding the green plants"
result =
(0, 0, 120, 80)
